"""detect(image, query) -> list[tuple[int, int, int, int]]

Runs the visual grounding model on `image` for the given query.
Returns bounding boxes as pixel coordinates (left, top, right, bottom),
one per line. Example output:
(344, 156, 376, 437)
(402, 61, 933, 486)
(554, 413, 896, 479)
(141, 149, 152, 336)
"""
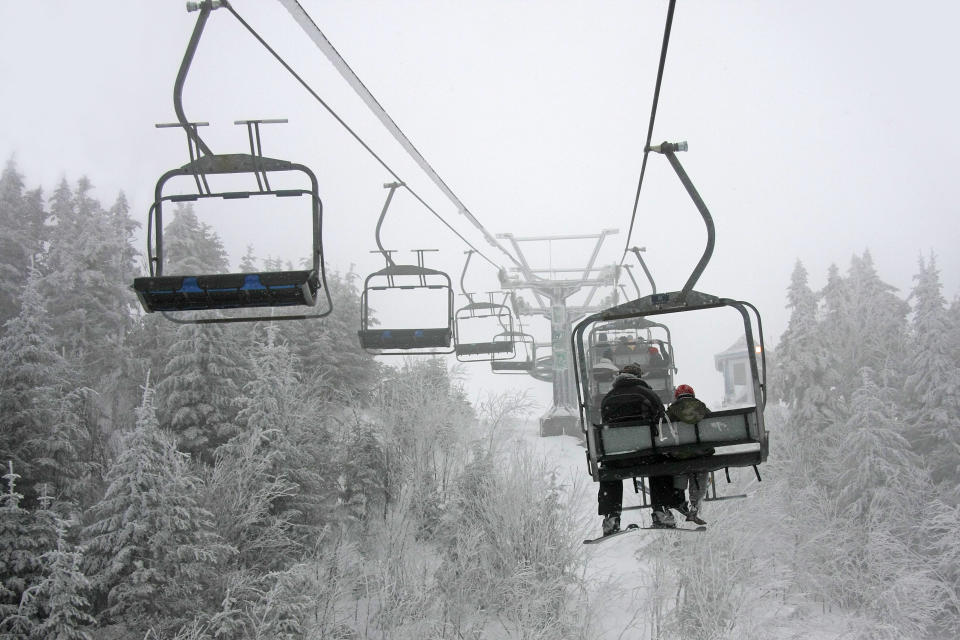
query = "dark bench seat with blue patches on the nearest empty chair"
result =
(133, 269, 320, 312)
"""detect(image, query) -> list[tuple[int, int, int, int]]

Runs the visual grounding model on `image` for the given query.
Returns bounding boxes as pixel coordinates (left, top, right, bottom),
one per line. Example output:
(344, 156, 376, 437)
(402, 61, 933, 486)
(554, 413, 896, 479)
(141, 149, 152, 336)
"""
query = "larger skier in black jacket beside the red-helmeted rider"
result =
(597, 362, 683, 536)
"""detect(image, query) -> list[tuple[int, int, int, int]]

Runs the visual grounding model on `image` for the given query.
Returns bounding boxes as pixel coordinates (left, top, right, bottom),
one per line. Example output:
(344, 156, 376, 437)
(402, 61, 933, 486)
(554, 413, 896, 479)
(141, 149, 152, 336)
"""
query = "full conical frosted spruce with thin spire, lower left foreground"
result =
(84, 386, 224, 630)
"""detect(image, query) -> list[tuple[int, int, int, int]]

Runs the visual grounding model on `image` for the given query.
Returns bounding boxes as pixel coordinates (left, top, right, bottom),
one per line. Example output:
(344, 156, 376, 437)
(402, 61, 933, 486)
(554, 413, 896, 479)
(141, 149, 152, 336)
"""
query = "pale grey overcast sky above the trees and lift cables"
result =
(0, 0, 960, 408)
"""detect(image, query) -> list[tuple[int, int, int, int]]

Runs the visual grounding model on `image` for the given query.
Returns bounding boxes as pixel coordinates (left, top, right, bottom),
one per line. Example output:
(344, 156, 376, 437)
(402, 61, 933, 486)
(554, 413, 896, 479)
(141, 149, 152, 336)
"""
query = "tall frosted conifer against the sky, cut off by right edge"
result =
(905, 256, 960, 492)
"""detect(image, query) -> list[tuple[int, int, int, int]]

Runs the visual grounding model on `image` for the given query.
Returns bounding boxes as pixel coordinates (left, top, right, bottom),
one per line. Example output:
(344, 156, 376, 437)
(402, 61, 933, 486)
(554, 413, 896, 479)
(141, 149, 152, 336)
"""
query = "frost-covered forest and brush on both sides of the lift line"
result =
(0, 156, 960, 640)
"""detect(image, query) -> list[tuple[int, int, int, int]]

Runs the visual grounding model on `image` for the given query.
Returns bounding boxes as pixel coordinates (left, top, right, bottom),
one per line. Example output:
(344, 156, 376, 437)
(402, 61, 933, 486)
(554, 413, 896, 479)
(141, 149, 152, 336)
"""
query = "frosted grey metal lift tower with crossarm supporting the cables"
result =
(497, 229, 619, 438)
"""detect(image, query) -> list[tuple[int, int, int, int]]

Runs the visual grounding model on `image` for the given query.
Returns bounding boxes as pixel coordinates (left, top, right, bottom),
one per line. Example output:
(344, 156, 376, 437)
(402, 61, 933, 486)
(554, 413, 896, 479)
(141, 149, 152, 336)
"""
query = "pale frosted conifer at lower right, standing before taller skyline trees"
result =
(822, 368, 943, 637)
